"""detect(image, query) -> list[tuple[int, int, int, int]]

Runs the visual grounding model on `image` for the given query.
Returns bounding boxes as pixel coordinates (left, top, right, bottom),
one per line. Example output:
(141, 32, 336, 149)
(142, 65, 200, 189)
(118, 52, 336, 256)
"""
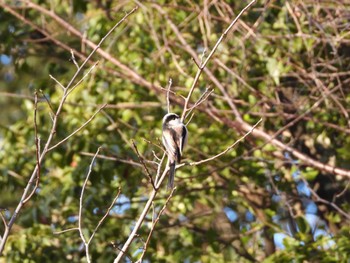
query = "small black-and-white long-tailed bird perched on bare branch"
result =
(162, 113, 188, 189)
